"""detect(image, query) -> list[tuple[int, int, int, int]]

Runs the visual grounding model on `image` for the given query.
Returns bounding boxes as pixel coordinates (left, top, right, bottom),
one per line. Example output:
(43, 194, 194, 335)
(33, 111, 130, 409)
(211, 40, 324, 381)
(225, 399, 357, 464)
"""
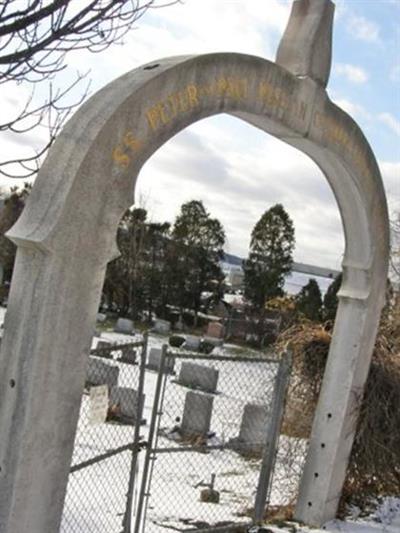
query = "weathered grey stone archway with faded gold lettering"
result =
(0, 0, 388, 533)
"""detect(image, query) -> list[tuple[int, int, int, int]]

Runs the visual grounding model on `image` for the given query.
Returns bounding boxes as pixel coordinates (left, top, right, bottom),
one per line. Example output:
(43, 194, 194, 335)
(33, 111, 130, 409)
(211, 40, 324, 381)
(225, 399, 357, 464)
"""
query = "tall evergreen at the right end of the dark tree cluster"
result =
(168, 200, 225, 322)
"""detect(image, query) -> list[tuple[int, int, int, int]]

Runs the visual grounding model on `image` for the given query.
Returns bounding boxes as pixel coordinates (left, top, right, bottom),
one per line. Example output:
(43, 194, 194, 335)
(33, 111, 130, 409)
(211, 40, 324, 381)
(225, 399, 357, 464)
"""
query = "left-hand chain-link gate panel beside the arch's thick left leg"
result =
(60, 334, 147, 533)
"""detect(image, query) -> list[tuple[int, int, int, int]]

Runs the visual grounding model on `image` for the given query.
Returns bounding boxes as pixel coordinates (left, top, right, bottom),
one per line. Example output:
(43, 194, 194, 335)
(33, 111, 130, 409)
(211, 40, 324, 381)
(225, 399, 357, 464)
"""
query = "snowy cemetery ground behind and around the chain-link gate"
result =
(0, 307, 400, 533)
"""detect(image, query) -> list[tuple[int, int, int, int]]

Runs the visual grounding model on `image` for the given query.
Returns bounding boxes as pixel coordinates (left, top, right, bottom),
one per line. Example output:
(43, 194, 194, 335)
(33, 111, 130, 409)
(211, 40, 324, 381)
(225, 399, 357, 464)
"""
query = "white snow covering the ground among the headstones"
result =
(0, 307, 400, 533)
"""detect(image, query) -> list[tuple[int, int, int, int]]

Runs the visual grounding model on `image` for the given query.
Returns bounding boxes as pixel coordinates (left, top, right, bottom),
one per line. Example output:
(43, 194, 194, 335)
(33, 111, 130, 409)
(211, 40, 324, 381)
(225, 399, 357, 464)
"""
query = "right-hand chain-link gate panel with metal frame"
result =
(134, 347, 290, 533)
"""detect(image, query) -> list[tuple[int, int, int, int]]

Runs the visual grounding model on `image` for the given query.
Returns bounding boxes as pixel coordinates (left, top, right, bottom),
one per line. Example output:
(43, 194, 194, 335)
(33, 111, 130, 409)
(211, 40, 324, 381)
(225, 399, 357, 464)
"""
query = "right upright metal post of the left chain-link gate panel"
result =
(122, 331, 148, 533)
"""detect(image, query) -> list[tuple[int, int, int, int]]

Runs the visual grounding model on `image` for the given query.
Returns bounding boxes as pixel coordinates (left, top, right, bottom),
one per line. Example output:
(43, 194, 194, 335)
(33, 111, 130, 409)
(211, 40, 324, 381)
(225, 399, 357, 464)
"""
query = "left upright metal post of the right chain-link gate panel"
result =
(134, 345, 167, 533)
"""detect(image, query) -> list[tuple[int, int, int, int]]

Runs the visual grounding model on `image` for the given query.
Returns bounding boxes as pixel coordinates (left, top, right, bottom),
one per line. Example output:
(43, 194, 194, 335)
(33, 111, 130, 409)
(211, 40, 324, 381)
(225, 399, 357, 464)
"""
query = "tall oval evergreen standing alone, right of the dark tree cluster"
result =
(243, 204, 295, 313)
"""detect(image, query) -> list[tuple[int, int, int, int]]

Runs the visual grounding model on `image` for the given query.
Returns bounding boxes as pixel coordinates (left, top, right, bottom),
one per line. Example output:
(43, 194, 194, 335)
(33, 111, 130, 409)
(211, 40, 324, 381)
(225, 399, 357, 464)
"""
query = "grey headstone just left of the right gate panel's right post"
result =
(236, 403, 269, 453)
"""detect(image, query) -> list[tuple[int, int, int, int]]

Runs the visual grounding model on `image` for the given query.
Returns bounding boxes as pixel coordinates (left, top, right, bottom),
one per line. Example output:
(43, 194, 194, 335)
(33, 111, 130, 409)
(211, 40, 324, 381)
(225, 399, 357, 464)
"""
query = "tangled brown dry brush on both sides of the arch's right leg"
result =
(278, 297, 400, 505)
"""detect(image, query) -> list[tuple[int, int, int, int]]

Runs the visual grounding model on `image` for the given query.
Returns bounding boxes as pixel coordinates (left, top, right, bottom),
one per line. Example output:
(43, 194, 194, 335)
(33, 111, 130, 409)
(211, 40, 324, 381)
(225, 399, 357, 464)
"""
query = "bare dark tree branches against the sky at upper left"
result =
(0, 0, 180, 179)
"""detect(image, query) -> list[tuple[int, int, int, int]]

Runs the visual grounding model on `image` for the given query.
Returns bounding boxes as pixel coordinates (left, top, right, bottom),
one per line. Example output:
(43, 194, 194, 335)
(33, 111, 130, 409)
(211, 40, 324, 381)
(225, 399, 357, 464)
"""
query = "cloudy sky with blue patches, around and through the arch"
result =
(0, 0, 400, 268)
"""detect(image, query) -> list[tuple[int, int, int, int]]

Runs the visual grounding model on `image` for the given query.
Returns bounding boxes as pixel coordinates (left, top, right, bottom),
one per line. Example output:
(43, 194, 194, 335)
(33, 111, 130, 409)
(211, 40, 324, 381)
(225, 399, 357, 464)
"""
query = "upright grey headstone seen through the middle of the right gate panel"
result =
(181, 391, 214, 437)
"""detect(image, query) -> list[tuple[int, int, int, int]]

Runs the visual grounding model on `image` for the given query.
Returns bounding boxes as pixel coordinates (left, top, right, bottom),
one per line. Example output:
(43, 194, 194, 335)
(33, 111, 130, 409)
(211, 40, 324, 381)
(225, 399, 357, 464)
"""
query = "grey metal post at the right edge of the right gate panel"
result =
(254, 351, 292, 524)
